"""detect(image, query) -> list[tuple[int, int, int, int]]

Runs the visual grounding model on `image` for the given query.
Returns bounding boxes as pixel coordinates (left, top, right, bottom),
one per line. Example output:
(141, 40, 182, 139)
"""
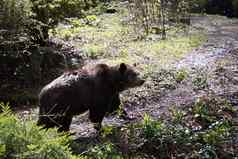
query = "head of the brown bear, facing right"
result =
(115, 63, 145, 91)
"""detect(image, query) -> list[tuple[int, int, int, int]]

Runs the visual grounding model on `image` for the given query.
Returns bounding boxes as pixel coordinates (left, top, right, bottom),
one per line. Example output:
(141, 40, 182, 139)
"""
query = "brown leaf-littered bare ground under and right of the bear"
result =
(15, 16, 238, 137)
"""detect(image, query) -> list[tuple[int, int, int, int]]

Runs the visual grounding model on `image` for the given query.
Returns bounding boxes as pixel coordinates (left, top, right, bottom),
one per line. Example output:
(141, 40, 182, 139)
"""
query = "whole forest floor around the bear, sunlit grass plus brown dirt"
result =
(15, 4, 238, 140)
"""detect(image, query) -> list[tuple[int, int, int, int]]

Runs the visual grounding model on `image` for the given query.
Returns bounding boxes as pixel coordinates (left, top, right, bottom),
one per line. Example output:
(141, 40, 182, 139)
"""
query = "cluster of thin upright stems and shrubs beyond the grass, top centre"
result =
(129, 0, 190, 39)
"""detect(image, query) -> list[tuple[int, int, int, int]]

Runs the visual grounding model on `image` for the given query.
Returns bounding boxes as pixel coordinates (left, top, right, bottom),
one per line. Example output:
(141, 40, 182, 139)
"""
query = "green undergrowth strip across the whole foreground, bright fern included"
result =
(0, 92, 238, 159)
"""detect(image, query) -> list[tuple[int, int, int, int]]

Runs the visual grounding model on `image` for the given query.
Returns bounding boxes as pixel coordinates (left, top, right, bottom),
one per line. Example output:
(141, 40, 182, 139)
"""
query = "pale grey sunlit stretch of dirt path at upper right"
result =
(177, 16, 238, 69)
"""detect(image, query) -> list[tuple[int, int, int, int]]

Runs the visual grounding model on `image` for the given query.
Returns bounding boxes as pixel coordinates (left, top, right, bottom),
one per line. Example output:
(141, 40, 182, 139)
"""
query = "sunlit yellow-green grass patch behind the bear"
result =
(52, 6, 206, 76)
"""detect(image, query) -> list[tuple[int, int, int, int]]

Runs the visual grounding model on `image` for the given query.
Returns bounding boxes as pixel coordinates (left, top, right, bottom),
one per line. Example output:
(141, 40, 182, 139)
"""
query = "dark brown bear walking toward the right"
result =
(38, 63, 145, 131)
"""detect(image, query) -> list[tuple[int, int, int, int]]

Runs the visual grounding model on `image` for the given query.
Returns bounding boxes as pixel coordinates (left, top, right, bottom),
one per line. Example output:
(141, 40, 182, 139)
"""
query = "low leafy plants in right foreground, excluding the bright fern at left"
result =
(70, 94, 237, 159)
